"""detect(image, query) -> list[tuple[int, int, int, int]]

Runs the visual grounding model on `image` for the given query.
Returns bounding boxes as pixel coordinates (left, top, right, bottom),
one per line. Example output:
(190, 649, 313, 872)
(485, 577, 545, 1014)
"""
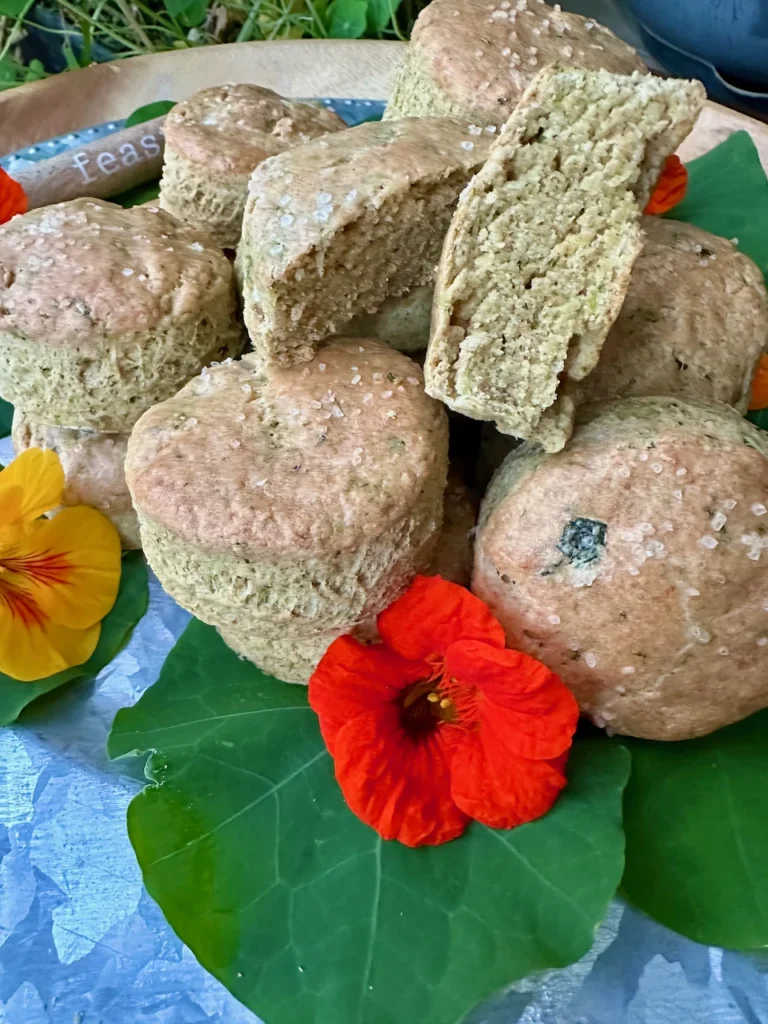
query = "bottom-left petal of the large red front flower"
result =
(334, 708, 467, 846)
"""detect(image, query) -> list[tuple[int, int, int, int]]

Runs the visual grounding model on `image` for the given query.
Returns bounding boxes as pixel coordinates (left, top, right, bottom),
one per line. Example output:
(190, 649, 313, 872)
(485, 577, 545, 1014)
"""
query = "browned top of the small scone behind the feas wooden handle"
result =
(165, 84, 346, 174)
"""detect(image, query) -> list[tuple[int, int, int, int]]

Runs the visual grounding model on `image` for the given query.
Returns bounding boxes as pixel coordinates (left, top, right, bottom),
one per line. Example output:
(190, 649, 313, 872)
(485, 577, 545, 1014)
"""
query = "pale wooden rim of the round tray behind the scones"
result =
(0, 39, 768, 171)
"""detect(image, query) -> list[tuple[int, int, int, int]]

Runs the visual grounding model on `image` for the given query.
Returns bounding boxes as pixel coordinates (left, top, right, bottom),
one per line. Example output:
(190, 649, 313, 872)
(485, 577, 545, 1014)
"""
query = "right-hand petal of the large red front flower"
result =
(445, 640, 579, 760)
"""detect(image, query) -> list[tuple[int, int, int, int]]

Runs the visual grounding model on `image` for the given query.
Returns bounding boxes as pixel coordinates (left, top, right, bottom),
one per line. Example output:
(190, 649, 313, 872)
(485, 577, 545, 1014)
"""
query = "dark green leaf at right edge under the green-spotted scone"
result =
(623, 711, 768, 949)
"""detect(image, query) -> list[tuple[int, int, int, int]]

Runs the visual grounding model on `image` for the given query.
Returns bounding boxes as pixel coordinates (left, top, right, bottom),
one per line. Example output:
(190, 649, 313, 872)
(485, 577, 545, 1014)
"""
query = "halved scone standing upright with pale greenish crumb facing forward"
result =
(423, 67, 705, 451)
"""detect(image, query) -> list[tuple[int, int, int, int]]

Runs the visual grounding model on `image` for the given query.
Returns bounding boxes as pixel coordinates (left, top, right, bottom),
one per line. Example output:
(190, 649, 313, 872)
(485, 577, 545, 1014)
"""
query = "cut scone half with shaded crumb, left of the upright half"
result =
(238, 118, 489, 367)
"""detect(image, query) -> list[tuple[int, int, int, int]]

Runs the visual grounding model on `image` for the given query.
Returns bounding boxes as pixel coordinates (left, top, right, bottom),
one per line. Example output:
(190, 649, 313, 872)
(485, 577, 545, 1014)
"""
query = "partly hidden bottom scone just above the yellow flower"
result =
(12, 410, 141, 549)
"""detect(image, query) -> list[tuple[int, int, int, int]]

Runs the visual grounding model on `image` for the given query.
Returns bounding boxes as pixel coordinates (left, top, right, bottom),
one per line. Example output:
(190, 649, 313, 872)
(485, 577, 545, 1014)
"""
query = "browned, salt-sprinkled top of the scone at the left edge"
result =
(0, 199, 232, 346)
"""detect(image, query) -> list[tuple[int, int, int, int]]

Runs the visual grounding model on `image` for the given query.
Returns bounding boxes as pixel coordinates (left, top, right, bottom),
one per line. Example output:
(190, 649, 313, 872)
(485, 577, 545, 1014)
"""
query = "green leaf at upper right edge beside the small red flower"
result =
(670, 131, 768, 280)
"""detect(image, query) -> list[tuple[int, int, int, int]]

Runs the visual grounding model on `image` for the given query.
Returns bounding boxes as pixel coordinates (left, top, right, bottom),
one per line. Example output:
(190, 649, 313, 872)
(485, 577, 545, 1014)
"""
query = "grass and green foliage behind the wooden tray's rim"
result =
(0, 0, 427, 90)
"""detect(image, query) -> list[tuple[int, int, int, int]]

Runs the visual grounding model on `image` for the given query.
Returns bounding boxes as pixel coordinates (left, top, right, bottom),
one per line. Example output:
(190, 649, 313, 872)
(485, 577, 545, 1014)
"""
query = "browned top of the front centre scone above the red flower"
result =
(126, 338, 447, 557)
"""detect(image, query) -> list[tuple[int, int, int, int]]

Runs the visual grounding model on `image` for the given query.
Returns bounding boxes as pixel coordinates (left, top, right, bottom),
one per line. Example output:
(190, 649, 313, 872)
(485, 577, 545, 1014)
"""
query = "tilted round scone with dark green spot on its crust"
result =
(472, 398, 768, 739)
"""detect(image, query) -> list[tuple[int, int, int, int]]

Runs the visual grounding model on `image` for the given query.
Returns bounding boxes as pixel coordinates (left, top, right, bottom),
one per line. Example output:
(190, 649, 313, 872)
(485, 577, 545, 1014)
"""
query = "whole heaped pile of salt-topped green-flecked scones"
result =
(13, 0, 768, 738)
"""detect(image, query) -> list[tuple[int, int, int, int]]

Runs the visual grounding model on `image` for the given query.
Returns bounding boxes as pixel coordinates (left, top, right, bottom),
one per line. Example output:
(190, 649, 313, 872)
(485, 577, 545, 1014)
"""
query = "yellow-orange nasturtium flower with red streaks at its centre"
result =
(0, 449, 120, 682)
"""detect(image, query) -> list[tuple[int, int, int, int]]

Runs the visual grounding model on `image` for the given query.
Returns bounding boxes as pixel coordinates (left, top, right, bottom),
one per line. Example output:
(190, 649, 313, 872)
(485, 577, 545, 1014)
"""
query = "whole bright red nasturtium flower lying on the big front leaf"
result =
(309, 577, 579, 846)
